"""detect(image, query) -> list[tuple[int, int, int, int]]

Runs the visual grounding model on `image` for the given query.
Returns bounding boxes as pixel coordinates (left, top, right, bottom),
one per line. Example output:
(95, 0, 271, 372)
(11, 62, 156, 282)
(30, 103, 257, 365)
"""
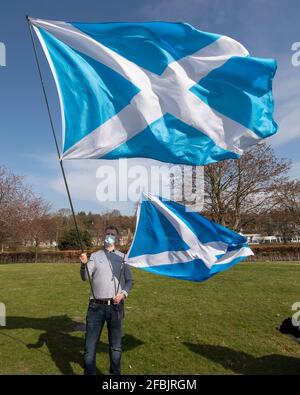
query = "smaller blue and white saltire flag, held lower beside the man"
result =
(126, 193, 253, 281)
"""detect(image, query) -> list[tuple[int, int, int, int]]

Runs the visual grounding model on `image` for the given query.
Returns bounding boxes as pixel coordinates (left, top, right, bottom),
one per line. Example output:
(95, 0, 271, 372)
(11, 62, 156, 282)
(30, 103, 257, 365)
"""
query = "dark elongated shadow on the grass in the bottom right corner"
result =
(183, 342, 300, 375)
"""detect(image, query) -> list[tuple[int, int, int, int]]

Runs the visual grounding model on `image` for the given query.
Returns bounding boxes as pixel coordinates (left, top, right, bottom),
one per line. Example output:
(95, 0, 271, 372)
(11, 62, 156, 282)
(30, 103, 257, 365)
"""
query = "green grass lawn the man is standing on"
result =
(0, 262, 300, 374)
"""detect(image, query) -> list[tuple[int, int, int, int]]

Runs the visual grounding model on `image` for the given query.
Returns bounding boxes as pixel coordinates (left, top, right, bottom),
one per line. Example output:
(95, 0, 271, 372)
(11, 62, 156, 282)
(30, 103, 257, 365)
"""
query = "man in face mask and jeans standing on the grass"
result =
(80, 225, 132, 375)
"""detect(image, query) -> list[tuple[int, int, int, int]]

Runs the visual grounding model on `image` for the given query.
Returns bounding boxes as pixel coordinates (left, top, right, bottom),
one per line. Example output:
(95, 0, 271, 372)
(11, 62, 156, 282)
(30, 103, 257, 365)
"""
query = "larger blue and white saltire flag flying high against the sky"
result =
(30, 18, 277, 165)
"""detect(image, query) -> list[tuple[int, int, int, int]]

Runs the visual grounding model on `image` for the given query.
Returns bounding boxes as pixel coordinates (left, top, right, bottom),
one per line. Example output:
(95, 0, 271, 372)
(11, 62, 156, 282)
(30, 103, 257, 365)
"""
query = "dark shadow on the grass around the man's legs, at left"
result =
(0, 315, 143, 375)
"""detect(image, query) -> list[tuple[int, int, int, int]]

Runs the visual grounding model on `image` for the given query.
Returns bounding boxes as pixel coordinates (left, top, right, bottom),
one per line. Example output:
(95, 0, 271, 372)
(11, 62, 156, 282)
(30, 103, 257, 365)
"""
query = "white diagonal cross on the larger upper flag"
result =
(32, 19, 259, 159)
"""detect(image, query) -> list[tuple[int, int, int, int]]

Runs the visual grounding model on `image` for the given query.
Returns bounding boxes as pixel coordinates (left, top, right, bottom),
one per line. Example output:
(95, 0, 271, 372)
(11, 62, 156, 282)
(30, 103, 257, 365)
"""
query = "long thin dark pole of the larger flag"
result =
(26, 15, 96, 299)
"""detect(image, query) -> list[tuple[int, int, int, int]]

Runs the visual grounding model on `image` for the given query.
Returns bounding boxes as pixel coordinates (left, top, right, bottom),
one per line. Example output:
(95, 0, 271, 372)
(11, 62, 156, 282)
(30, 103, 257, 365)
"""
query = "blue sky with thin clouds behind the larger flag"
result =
(0, 0, 300, 217)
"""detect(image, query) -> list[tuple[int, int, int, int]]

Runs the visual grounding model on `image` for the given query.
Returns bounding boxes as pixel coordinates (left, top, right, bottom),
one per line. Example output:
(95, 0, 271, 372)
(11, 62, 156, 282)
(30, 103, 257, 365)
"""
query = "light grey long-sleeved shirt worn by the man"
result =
(80, 250, 133, 299)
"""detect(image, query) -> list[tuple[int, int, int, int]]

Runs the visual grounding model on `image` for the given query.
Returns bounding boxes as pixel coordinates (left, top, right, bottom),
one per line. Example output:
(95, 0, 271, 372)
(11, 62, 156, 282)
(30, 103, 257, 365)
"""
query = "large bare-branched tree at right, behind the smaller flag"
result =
(205, 142, 290, 230)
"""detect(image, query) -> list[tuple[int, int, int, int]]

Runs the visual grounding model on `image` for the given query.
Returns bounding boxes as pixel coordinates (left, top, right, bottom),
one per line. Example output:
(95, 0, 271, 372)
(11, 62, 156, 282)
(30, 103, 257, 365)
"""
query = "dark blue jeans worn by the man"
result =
(84, 301, 124, 375)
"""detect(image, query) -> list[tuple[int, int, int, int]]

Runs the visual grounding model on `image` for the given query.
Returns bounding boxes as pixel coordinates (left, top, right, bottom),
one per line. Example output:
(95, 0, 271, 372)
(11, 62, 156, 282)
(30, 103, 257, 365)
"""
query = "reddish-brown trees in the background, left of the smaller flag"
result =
(0, 166, 135, 254)
